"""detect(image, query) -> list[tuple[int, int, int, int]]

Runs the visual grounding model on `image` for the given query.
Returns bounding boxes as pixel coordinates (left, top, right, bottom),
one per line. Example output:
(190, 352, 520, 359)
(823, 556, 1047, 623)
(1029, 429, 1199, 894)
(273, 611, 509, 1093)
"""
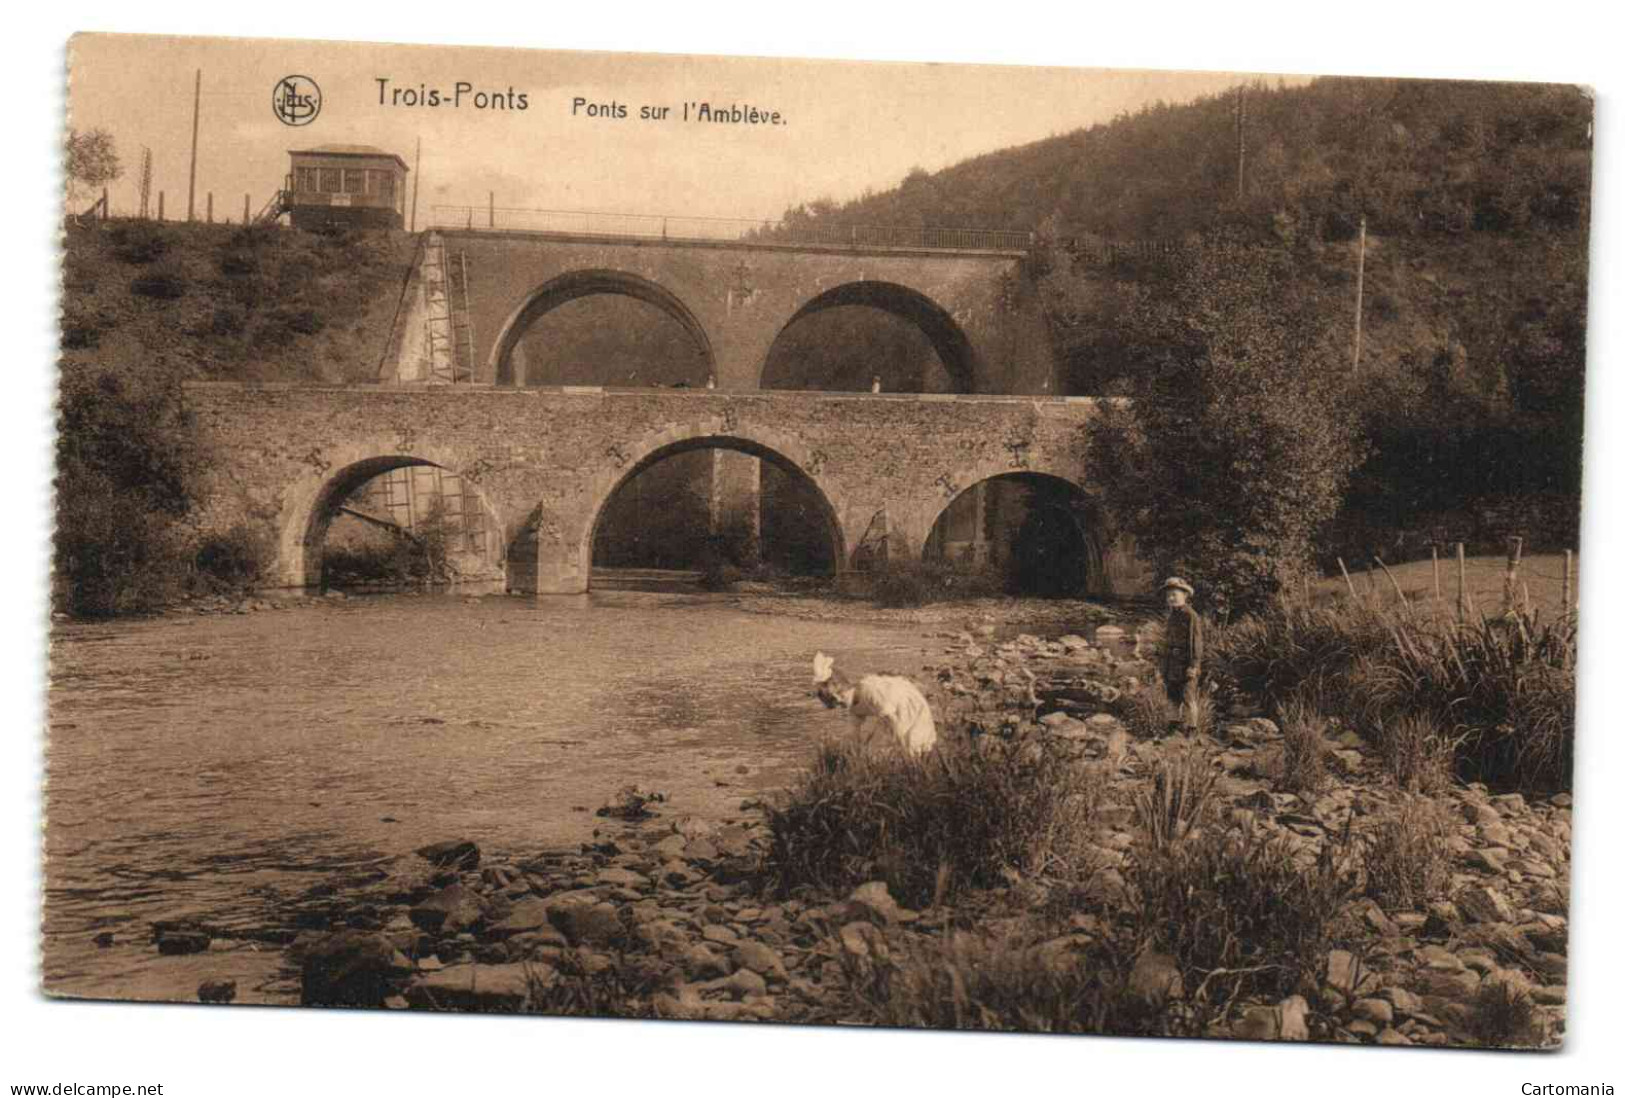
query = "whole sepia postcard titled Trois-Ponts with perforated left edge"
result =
(42, 34, 1586, 1052)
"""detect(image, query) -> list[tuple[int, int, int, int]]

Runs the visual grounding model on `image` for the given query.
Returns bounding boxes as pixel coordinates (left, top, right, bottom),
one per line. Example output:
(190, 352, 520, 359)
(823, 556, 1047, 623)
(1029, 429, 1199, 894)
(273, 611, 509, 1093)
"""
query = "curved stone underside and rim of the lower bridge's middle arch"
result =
(575, 421, 850, 578)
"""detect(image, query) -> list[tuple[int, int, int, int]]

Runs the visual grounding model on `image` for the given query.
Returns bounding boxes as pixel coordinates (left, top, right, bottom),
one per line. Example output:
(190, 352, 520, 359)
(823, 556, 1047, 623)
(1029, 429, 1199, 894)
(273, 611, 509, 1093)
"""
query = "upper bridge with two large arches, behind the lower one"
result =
(393, 227, 1053, 393)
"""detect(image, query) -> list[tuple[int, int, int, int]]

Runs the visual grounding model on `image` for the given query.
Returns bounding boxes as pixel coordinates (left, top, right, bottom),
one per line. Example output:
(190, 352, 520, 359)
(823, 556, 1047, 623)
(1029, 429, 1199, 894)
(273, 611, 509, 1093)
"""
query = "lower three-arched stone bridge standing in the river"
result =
(185, 382, 1136, 593)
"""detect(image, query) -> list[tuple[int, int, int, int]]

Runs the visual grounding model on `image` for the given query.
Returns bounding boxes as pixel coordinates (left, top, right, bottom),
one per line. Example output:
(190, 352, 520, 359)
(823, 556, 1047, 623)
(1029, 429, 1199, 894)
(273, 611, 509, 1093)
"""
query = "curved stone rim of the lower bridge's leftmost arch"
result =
(276, 439, 502, 586)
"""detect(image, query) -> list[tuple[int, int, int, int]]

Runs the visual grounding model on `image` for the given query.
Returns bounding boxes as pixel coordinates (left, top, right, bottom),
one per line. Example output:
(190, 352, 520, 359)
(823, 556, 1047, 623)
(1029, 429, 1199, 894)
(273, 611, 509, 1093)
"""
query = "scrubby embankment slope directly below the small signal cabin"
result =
(63, 221, 416, 383)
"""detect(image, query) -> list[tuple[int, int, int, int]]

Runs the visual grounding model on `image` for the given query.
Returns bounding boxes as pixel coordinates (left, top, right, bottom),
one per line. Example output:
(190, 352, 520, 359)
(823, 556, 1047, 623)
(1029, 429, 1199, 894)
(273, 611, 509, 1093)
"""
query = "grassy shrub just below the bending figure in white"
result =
(764, 734, 1103, 906)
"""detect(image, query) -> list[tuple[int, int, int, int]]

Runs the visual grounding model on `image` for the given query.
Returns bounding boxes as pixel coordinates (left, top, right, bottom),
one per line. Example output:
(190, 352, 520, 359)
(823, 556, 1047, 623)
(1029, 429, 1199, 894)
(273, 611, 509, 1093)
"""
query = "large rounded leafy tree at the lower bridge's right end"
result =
(1086, 245, 1362, 612)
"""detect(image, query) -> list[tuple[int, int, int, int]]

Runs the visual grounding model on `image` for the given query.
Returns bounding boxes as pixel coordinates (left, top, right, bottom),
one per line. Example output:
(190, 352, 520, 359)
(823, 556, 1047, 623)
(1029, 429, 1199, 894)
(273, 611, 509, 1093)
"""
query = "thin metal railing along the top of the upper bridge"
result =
(429, 205, 1034, 252)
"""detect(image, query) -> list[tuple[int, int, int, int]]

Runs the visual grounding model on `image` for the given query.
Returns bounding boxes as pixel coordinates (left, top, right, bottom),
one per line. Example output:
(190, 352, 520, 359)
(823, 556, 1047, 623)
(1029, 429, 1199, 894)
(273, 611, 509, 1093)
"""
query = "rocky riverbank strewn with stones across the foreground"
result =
(154, 632, 1571, 1048)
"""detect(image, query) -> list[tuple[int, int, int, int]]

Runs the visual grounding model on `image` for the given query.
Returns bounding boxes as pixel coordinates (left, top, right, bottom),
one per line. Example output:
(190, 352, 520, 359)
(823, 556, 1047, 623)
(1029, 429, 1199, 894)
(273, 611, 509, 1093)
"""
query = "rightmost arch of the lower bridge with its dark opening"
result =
(921, 463, 1112, 594)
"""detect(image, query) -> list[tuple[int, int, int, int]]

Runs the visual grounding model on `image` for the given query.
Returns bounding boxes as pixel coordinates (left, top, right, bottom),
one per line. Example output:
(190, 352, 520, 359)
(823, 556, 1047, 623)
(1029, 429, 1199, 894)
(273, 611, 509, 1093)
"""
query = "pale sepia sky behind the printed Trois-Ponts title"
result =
(68, 34, 1280, 227)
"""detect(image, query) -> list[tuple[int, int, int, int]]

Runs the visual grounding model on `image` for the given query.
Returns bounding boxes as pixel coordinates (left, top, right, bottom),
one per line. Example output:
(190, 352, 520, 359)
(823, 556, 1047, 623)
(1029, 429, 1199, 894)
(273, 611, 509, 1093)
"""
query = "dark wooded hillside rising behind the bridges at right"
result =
(770, 78, 1593, 567)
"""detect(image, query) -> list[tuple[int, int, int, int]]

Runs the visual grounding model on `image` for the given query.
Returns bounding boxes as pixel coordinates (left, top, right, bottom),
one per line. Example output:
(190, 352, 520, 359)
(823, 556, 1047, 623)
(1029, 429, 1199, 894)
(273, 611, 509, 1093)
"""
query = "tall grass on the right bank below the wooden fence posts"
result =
(1214, 603, 1575, 789)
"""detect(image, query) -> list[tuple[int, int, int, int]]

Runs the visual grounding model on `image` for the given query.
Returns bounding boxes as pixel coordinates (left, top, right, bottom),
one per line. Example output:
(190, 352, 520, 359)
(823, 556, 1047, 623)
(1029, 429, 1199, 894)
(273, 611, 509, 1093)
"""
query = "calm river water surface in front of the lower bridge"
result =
(44, 591, 941, 1002)
